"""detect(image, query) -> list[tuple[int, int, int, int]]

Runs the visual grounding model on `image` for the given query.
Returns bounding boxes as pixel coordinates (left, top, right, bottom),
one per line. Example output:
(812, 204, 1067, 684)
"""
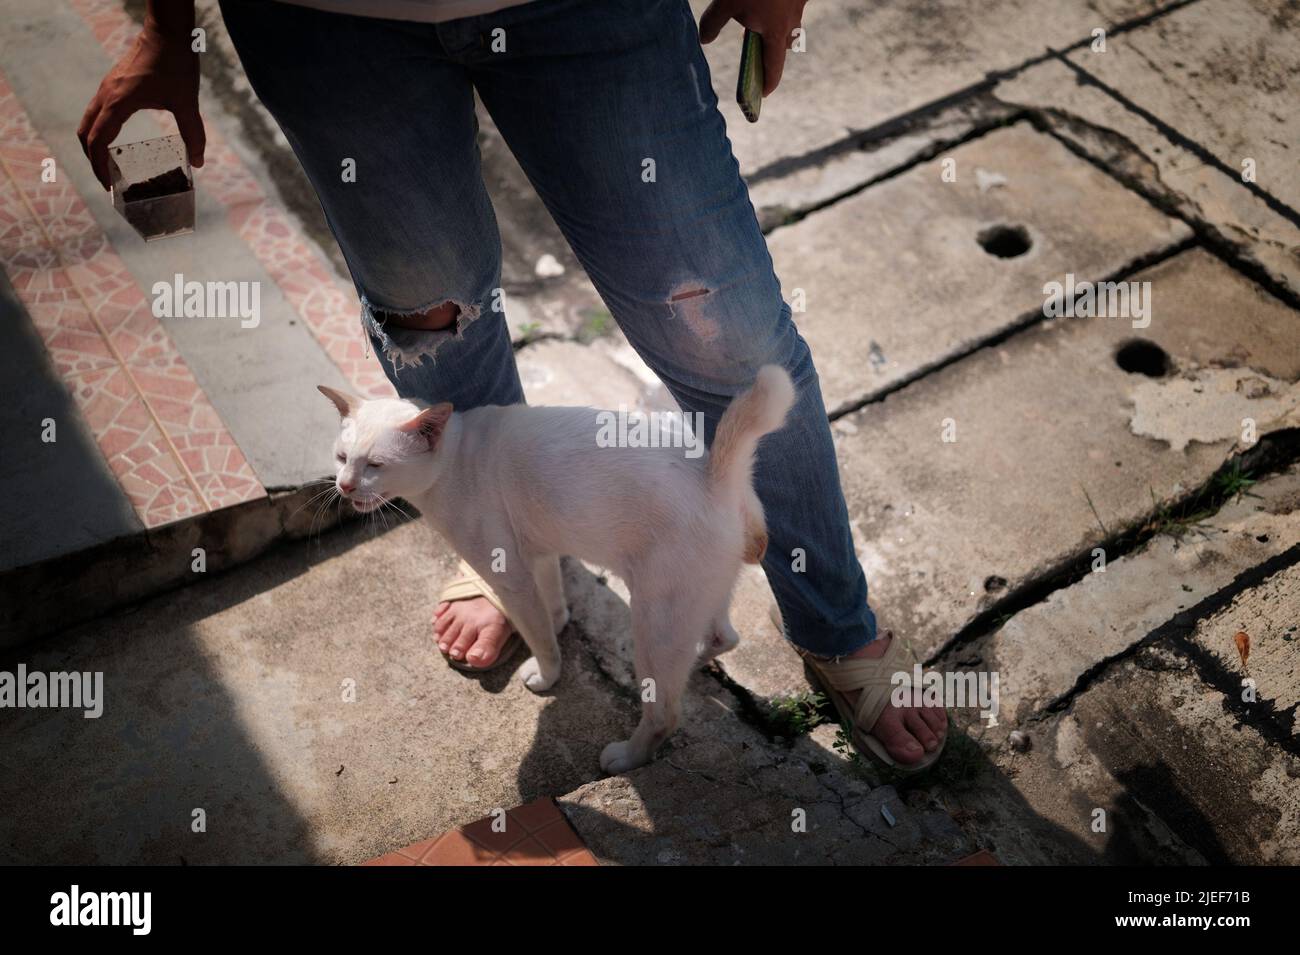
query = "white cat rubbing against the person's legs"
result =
(320, 365, 794, 773)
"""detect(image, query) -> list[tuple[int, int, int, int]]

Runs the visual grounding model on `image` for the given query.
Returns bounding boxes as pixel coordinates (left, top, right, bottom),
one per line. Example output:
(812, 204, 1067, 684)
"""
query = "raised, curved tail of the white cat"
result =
(709, 365, 794, 564)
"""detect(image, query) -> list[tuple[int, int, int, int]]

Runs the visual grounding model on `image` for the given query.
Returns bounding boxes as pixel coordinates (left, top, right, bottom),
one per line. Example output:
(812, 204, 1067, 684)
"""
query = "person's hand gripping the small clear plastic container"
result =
(77, 19, 207, 188)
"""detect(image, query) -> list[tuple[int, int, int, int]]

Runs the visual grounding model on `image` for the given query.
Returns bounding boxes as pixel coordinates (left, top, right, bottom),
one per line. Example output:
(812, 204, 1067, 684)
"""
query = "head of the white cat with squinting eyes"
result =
(317, 385, 451, 513)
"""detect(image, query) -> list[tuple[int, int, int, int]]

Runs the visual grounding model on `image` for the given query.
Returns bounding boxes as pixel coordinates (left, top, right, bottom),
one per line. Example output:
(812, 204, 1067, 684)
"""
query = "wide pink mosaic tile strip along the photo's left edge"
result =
(0, 74, 265, 528)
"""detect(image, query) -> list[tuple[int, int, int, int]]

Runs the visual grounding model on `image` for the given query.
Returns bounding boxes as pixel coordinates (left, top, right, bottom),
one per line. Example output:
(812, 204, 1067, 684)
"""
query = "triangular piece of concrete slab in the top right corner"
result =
(1070, 0, 1300, 214)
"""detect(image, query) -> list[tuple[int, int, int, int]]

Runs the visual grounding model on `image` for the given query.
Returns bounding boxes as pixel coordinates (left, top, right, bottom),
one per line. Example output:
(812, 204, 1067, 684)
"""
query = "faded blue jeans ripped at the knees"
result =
(221, 0, 876, 656)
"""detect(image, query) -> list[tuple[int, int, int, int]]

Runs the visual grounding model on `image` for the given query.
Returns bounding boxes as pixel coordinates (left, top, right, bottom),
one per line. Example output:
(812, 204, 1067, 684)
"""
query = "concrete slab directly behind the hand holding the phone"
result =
(692, 0, 1185, 174)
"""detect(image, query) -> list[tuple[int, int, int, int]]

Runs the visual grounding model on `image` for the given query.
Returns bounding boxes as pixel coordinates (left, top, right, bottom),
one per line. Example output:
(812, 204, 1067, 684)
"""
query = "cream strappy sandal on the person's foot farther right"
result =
(796, 630, 948, 776)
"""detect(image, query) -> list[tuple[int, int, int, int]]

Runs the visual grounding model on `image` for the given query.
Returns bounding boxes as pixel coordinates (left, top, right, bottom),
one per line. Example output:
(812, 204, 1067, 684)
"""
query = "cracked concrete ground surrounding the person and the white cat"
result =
(0, 0, 1300, 864)
